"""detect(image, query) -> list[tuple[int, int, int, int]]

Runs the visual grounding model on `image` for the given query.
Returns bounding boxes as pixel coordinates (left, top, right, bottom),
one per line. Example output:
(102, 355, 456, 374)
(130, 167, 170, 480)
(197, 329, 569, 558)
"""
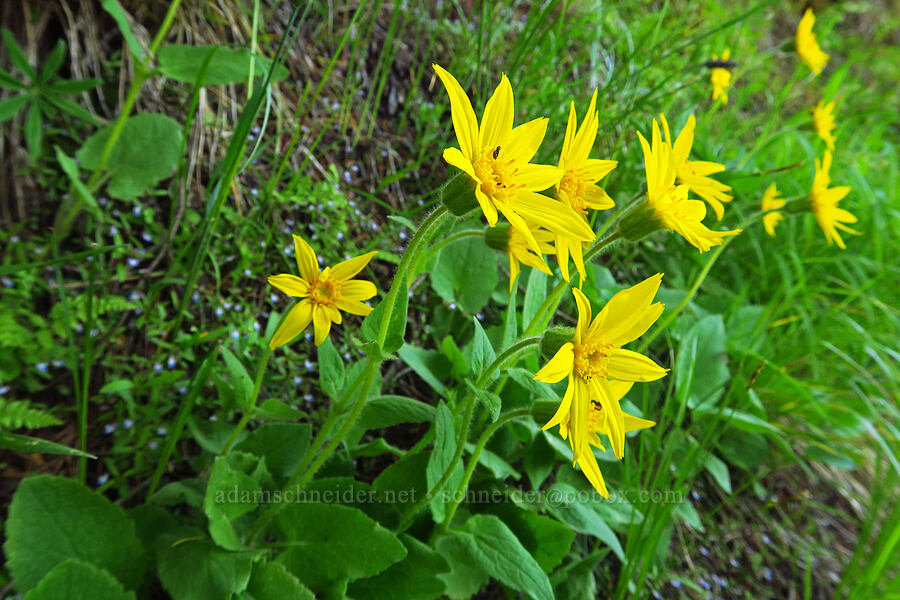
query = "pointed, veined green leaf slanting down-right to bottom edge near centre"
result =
(451, 515, 553, 600)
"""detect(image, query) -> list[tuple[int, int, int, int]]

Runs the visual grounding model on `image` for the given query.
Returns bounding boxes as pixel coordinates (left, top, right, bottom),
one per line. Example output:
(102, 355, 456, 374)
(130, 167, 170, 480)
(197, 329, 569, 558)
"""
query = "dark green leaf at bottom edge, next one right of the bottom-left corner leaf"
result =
(156, 527, 253, 600)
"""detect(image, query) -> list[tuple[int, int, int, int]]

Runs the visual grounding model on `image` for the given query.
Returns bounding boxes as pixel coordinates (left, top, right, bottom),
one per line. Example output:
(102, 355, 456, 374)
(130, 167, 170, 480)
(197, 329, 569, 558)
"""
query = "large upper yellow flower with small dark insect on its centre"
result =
(432, 64, 594, 252)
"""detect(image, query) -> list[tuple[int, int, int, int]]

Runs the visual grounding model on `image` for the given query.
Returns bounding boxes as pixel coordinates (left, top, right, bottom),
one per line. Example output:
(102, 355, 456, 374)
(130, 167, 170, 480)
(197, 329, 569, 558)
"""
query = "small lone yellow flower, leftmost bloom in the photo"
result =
(268, 235, 378, 350)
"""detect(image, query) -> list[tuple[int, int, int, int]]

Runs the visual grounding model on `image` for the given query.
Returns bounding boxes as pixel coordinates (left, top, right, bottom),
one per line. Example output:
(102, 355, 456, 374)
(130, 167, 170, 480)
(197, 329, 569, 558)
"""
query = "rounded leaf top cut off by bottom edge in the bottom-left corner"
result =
(25, 560, 134, 600)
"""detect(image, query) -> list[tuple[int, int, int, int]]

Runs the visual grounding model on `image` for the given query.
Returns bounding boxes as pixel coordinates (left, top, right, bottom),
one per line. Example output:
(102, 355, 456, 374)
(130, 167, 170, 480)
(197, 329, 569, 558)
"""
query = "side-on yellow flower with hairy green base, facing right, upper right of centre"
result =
(619, 119, 741, 252)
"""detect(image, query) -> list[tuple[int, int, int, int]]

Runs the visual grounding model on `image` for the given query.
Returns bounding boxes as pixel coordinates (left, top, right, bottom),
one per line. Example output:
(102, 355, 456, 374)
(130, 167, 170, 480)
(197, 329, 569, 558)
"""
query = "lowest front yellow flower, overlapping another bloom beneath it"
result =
(534, 274, 668, 461)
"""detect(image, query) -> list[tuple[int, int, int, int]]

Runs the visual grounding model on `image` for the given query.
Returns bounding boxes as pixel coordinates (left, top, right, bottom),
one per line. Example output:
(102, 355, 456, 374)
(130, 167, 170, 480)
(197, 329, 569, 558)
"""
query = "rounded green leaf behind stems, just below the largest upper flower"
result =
(431, 239, 497, 314)
